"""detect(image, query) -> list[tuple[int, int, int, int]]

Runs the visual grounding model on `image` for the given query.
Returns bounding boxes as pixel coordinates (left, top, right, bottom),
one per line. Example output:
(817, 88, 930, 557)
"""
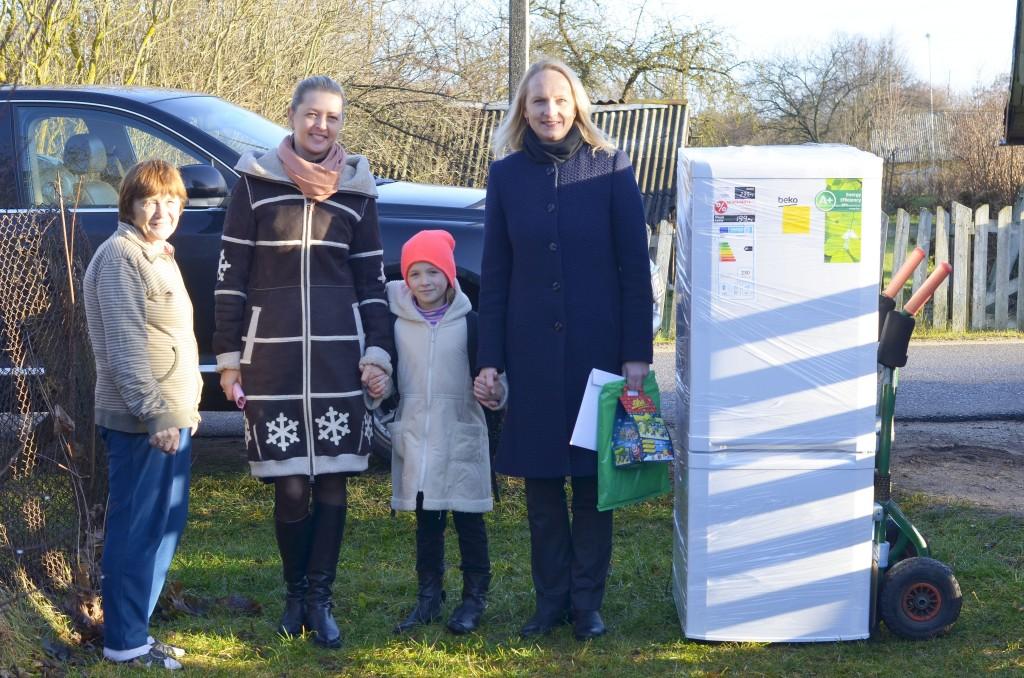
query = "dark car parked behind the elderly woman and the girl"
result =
(0, 87, 484, 408)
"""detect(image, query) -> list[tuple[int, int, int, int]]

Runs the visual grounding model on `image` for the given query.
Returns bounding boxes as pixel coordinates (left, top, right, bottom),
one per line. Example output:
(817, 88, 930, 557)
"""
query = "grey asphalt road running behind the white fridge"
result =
(200, 340, 1024, 446)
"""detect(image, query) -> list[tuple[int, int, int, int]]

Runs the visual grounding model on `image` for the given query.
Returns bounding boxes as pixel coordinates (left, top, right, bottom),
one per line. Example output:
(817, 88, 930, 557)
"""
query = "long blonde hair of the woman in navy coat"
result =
(490, 58, 615, 159)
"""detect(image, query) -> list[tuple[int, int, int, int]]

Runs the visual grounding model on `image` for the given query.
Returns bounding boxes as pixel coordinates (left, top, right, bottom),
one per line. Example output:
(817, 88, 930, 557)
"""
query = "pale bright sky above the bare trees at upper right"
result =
(647, 0, 1017, 92)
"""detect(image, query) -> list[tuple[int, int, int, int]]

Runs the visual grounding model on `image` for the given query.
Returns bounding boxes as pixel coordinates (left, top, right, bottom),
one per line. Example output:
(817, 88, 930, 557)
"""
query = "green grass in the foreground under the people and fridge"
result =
(0, 464, 1024, 678)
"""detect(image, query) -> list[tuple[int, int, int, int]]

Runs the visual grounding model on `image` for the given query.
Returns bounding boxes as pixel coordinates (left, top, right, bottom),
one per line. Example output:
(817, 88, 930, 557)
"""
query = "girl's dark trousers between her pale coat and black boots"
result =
(416, 493, 490, 575)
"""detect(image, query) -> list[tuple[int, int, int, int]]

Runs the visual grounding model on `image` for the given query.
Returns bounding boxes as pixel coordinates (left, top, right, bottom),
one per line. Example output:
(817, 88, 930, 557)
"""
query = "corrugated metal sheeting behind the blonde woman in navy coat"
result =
(374, 101, 687, 224)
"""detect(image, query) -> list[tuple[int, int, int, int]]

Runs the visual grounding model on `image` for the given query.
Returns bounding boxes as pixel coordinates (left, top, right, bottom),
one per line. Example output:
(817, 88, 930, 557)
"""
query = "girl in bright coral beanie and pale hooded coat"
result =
(368, 230, 505, 634)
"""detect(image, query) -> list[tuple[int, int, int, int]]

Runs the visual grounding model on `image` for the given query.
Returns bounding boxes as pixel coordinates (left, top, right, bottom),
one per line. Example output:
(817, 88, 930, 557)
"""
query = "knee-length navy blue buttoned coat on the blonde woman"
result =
(477, 144, 652, 477)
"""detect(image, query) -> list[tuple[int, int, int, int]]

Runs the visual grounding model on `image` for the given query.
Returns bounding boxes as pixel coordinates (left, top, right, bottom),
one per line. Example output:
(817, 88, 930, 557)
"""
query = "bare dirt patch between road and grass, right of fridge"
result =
(892, 421, 1024, 515)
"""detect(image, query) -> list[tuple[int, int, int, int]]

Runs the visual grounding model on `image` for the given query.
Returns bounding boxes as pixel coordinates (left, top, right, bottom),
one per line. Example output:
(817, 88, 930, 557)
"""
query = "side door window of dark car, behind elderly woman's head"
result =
(17, 107, 211, 208)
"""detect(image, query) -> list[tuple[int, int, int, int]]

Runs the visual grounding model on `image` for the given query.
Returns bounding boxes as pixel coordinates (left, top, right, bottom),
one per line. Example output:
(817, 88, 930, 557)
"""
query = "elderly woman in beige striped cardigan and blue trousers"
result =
(84, 160, 203, 669)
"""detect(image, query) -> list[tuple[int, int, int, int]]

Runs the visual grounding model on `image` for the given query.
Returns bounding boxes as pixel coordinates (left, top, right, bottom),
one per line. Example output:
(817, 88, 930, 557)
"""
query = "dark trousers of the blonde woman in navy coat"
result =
(526, 476, 611, 613)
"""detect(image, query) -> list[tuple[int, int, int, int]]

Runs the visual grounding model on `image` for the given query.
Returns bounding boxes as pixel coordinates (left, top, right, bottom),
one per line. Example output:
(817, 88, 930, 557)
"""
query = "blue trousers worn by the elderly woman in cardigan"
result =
(99, 427, 191, 653)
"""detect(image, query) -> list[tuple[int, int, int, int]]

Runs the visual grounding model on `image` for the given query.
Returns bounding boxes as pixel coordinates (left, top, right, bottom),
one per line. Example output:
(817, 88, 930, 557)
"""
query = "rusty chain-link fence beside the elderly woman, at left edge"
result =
(0, 210, 106, 610)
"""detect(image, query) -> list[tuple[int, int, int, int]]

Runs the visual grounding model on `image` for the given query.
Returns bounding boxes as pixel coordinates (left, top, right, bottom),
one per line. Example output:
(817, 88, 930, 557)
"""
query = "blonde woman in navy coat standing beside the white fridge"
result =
(477, 60, 652, 640)
